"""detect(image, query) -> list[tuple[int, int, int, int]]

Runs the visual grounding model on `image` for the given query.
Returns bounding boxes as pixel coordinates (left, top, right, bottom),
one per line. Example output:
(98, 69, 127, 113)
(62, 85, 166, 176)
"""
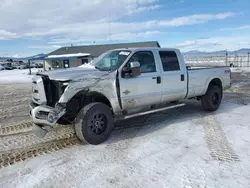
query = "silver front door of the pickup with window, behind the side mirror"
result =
(120, 51, 161, 110)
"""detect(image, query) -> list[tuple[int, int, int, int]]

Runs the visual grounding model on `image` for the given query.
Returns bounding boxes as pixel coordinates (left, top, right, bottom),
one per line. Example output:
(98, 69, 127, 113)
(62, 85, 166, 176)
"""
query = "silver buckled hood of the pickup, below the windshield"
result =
(37, 64, 108, 81)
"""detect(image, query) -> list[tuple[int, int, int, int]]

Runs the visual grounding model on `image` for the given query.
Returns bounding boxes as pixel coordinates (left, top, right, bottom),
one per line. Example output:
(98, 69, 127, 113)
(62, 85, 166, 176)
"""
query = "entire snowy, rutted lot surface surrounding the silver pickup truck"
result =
(0, 69, 250, 188)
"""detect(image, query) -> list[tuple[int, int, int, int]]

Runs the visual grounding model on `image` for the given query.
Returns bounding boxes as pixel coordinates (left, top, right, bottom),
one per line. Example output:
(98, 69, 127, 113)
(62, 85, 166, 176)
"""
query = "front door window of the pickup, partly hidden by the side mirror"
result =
(127, 51, 156, 73)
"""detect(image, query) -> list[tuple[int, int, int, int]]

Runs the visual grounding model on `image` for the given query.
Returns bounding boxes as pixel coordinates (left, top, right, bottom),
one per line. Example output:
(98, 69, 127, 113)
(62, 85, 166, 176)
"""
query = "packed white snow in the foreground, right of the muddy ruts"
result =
(0, 103, 250, 188)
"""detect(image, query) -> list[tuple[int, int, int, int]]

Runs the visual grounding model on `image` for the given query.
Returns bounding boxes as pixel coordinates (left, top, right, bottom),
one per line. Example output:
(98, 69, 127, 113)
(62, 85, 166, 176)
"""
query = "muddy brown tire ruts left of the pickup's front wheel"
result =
(0, 122, 79, 168)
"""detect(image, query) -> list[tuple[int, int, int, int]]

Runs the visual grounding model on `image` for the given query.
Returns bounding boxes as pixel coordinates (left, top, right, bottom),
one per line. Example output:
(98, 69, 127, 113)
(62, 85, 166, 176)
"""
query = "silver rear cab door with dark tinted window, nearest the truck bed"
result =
(158, 50, 187, 102)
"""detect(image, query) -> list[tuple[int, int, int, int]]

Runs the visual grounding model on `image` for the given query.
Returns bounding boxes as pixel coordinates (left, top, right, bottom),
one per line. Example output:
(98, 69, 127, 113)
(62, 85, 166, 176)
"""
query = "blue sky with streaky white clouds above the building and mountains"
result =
(0, 0, 250, 57)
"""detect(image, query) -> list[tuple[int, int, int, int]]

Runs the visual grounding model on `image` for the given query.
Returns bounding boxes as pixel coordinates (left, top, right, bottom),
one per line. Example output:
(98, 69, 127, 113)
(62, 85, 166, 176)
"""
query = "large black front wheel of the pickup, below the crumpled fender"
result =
(75, 102, 114, 145)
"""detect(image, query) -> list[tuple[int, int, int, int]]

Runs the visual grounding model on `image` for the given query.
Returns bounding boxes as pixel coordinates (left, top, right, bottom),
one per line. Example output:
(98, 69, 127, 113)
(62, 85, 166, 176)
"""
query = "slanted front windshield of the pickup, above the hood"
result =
(91, 50, 131, 71)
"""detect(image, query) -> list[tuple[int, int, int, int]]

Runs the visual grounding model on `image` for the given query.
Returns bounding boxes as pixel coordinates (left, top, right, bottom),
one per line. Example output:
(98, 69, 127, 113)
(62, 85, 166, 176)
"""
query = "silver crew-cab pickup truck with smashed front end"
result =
(30, 48, 231, 144)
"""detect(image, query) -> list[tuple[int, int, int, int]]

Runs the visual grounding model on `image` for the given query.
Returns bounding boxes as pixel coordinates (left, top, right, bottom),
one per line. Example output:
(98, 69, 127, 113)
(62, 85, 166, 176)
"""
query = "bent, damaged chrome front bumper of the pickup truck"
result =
(29, 101, 66, 137)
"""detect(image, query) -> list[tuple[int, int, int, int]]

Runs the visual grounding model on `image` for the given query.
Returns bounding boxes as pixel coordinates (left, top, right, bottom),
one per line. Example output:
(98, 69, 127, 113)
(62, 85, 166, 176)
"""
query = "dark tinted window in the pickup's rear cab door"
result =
(159, 51, 180, 71)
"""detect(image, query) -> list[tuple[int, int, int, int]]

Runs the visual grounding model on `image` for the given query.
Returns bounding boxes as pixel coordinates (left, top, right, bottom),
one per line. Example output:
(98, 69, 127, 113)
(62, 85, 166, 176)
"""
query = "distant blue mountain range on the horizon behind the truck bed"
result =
(183, 48, 250, 56)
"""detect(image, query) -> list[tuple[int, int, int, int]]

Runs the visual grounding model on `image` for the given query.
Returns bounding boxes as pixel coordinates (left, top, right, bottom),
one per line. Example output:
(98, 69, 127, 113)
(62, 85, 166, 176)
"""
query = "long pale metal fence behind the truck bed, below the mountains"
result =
(184, 53, 250, 67)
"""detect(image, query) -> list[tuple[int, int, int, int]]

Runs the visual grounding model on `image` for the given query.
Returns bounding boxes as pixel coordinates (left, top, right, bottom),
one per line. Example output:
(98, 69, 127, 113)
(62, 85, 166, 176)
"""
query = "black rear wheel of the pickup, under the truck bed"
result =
(201, 85, 222, 111)
